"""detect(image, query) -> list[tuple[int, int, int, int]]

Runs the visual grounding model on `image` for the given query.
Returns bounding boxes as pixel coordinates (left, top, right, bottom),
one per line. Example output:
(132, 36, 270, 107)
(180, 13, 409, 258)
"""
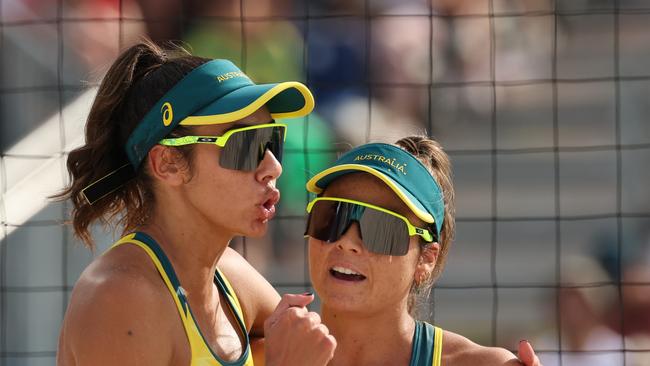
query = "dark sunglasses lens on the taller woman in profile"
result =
(219, 126, 284, 171)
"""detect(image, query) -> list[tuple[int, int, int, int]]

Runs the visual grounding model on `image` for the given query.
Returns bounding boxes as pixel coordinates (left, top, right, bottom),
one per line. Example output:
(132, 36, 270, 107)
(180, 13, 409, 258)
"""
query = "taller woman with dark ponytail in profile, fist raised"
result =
(57, 41, 336, 365)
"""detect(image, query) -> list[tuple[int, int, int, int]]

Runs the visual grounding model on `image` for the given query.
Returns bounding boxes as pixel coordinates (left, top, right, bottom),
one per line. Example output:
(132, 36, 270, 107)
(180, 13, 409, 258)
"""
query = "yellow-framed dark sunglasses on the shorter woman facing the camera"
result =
(305, 197, 437, 255)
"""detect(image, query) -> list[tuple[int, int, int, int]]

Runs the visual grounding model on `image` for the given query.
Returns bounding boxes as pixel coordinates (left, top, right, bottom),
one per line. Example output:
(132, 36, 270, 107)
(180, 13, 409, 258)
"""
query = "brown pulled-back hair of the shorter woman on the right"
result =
(395, 135, 456, 312)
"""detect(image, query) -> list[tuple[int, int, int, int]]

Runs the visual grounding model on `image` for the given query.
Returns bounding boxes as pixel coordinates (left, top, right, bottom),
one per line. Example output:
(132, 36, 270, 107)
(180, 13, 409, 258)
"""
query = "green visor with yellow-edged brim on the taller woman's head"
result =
(82, 60, 314, 204)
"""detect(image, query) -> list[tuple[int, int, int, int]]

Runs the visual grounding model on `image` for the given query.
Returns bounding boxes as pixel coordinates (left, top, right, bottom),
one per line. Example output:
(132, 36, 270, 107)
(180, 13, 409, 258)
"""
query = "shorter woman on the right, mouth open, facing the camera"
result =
(305, 136, 539, 366)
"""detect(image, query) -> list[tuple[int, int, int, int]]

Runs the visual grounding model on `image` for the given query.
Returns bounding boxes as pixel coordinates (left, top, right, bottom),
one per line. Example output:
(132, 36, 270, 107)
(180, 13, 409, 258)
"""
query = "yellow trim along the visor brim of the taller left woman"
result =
(180, 81, 315, 126)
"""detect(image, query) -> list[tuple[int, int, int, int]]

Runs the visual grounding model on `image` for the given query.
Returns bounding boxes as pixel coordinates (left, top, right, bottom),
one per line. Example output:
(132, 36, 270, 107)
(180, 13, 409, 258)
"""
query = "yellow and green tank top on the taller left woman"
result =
(111, 232, 253, 366)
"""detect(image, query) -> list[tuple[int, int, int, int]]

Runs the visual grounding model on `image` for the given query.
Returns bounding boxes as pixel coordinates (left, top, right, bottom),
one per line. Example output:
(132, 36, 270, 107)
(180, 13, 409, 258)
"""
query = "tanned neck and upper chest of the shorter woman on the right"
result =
(321, 304, 415, 366)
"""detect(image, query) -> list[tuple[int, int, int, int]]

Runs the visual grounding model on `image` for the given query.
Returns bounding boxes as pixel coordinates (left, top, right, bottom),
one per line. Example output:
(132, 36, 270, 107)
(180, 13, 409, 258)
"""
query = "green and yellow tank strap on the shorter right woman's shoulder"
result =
(409, 321, 442, 366)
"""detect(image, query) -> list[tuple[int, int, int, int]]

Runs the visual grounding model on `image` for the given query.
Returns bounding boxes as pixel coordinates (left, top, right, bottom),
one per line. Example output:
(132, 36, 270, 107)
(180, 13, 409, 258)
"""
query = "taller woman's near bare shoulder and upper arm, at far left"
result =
(59, 245, 179, 365)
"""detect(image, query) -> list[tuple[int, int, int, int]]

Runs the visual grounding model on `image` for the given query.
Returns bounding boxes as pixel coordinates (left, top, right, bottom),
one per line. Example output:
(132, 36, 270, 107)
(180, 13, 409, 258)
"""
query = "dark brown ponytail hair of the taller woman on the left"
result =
(54, 39, 209, 249)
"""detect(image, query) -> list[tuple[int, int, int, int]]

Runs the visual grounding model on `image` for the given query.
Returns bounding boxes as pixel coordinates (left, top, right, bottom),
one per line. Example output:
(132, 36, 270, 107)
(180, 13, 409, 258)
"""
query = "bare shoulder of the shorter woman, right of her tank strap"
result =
(442, 331, 521, 366)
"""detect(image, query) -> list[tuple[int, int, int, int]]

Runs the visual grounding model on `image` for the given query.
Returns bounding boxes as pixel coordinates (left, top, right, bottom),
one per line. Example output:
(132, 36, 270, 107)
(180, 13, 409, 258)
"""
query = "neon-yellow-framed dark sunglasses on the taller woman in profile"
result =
(159, 123, 287, 171)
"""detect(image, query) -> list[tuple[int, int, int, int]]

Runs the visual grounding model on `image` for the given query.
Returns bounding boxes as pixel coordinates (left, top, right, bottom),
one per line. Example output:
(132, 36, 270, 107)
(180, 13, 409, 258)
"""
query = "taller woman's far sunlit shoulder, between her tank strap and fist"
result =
(218, 248, 280, 336)
